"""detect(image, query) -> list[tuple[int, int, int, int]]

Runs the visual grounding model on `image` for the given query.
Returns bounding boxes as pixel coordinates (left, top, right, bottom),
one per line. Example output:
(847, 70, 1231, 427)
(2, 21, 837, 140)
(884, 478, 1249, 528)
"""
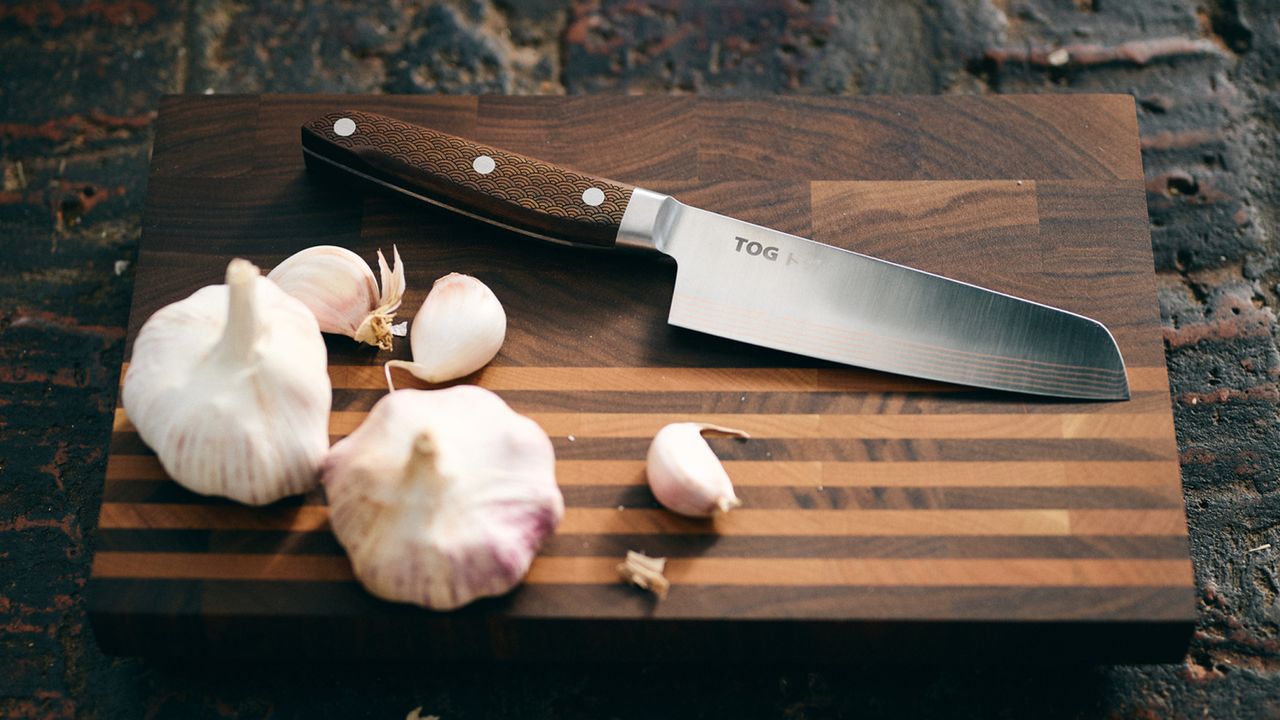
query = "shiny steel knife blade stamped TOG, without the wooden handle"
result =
(652, 199, 1129, 400)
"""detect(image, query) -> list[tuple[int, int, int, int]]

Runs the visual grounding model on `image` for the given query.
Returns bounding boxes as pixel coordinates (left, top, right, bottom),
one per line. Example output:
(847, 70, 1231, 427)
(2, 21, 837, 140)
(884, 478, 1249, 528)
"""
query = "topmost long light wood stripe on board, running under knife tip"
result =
(120, 363, 1169, 392)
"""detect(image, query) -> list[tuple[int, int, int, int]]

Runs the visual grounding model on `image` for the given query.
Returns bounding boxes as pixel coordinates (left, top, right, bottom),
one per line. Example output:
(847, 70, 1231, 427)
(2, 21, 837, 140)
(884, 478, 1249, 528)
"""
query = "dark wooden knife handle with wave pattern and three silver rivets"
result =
(302, 110, 635, 247)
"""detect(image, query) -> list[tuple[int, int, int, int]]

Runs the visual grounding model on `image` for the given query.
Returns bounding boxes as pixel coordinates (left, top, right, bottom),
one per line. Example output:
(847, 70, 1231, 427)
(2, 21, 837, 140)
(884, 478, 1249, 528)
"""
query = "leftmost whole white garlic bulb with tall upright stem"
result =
(123, 260, 332, 505)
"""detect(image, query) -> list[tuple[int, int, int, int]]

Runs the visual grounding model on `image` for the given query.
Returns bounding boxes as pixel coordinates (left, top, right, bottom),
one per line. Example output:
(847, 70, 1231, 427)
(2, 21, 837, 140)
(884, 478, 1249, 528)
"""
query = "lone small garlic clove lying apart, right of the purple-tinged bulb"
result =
(645, 423, 751, 518)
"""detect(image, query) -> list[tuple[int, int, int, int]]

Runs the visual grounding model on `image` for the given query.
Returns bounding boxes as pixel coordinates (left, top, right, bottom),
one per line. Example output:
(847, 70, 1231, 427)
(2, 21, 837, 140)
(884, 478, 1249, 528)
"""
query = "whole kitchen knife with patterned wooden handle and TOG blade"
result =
(302, 110, 1129, 400)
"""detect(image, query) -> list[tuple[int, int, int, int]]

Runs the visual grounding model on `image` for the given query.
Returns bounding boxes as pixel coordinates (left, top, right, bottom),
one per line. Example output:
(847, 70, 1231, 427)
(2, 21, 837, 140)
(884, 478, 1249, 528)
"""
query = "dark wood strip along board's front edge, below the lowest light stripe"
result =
(90, 577, 1196, 620)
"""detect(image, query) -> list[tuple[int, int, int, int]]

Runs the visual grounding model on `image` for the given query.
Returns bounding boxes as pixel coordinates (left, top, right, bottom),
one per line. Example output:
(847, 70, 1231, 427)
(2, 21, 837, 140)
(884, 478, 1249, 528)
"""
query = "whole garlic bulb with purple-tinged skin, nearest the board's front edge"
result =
(321, 386, 564, 610)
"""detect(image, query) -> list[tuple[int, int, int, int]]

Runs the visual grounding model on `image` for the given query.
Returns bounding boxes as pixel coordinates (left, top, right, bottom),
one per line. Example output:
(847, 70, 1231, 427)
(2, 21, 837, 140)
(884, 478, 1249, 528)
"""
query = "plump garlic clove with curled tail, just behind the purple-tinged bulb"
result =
(385, 273, 507, 389)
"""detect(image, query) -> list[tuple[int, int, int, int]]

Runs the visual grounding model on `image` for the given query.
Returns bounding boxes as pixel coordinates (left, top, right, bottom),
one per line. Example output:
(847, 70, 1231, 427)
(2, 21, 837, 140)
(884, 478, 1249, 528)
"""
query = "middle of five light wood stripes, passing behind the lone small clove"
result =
(106, 455, 1181, 492)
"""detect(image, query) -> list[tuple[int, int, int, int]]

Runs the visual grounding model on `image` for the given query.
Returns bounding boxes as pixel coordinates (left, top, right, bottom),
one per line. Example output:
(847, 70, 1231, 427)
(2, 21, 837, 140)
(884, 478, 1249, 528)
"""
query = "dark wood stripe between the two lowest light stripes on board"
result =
(97, 529, 1187, 560)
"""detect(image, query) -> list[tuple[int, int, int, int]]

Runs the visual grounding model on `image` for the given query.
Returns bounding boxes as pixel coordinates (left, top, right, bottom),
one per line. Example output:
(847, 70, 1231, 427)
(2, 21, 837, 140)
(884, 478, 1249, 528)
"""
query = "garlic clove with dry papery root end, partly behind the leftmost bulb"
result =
(266, 245, 404, 350)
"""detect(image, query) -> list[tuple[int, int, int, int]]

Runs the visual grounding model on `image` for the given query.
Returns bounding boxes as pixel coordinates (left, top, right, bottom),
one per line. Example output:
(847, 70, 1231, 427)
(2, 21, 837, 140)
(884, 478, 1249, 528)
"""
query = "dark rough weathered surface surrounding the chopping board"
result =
(0, 0, 1280, 720)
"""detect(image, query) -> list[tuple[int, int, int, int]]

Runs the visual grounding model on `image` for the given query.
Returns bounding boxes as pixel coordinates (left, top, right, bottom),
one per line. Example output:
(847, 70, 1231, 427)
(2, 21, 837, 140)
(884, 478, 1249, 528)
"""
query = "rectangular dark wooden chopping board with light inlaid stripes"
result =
(90, 95, 1194, 662)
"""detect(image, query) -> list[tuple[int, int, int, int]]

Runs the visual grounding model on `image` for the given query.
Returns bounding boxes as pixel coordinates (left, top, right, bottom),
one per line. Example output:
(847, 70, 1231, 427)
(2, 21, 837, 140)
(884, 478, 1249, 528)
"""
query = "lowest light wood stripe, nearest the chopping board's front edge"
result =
(93, 552, 1192, 592)
